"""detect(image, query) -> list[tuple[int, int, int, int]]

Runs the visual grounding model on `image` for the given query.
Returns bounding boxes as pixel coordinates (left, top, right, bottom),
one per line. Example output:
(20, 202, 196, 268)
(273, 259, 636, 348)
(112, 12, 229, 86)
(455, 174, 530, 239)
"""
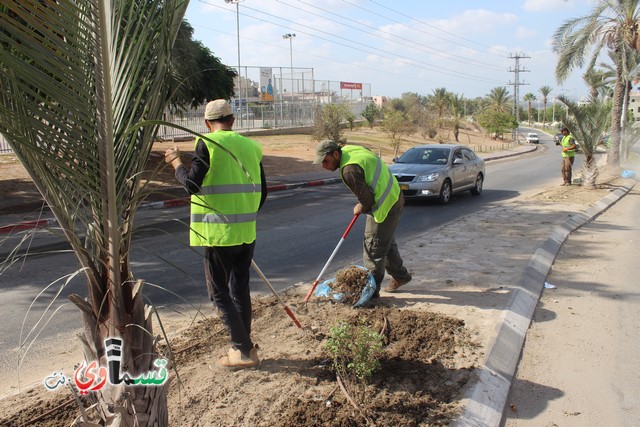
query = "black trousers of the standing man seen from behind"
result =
(204, 241, 256, 354)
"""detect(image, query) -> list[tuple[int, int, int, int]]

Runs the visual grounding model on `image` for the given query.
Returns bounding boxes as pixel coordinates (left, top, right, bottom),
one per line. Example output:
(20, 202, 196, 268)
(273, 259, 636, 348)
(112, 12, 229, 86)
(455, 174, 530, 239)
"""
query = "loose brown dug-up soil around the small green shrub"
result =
(0, 290, 481, 426)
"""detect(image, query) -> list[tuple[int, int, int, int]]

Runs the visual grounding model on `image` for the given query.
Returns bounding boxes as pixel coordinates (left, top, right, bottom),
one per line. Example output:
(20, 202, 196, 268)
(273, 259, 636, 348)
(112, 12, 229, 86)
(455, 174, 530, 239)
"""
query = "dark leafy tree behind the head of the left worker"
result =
(169, 20, 237, 109)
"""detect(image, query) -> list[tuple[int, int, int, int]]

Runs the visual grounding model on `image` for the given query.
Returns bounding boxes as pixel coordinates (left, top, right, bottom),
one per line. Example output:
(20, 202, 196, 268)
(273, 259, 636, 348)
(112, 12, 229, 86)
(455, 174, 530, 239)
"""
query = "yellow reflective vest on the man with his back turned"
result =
(189, 130, 262, 246)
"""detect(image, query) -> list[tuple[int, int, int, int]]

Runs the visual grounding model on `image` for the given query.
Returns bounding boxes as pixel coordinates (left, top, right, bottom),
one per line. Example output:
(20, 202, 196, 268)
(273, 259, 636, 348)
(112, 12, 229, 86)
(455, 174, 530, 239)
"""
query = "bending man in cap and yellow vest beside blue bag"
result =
(313, 140, 411, 298)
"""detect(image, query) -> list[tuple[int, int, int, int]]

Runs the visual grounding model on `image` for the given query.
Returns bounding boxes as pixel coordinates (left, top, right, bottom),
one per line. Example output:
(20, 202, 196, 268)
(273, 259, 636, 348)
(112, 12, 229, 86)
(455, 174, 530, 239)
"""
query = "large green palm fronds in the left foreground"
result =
(0, 0, 187, 312)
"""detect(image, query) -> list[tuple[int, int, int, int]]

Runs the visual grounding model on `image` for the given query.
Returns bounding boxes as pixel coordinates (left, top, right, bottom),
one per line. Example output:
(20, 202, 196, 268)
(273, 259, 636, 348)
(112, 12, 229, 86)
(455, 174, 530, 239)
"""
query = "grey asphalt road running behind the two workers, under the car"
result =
(0, 134, 568, 378)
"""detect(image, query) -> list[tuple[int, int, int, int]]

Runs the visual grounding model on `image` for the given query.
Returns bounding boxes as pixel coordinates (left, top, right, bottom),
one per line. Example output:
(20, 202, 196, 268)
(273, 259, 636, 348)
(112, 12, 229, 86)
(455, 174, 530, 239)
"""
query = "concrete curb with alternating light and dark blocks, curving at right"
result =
(454, 183, 635, 427)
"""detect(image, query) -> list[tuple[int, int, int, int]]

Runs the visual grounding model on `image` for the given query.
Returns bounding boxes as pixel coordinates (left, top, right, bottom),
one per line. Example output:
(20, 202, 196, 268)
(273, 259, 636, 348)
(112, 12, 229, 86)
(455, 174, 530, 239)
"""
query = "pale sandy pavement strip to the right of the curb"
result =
(504, 188, 640, 427)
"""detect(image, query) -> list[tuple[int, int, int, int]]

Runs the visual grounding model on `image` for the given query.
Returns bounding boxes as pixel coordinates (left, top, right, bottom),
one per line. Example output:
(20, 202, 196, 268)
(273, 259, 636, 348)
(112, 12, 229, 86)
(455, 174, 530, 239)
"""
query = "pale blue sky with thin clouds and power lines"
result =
(185, 0, 594, 100)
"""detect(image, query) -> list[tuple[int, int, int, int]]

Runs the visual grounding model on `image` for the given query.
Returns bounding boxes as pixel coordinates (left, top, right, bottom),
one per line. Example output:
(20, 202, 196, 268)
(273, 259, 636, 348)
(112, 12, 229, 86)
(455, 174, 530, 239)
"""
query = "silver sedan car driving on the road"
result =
(389, 144, 485, 204)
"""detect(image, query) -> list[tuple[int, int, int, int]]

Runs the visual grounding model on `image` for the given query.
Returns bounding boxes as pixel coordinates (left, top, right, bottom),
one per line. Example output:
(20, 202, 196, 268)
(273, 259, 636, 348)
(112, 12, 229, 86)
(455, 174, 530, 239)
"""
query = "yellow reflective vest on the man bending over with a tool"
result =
(340, 145, 400, 223)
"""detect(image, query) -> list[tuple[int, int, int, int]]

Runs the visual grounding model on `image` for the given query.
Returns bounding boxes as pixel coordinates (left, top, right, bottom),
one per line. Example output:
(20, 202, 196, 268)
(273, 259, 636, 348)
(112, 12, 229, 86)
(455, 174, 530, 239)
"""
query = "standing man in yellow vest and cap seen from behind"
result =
(165, 99, 267, 369)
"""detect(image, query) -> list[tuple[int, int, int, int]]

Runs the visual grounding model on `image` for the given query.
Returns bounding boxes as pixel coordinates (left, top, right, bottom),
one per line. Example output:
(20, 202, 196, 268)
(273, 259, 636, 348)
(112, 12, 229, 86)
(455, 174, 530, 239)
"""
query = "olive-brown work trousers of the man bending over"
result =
(363, 197, 408, 293)
